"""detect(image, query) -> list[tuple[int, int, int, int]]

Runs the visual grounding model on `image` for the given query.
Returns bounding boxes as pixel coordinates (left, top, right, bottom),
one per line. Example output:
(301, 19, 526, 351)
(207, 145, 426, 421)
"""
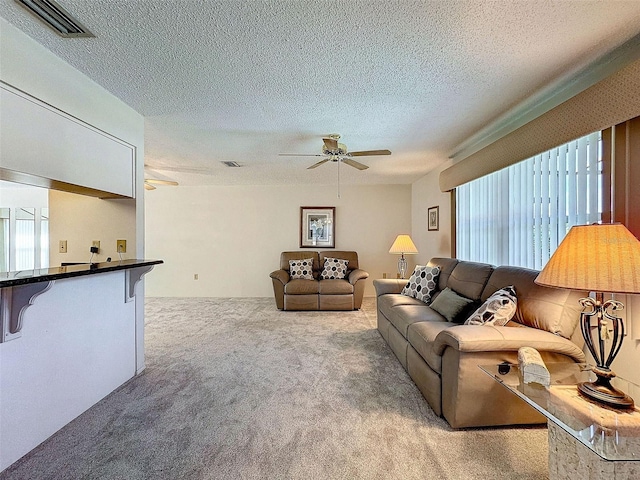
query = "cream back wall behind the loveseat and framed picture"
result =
(145, 185, 411, 297)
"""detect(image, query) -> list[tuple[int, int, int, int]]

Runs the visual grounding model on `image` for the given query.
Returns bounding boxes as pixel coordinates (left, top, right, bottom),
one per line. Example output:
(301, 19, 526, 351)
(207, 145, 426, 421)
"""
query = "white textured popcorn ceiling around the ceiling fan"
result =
(0, 0, 640, 185)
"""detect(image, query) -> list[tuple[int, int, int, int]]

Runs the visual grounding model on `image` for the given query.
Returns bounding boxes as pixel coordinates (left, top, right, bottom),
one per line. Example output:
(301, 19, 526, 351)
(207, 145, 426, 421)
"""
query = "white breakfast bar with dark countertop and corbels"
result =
(0, 260, 163, 472)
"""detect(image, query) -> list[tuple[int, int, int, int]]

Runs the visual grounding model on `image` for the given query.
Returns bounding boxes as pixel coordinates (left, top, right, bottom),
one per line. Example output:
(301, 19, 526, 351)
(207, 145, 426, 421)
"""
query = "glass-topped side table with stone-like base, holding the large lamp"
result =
(480, 363, 640, 480)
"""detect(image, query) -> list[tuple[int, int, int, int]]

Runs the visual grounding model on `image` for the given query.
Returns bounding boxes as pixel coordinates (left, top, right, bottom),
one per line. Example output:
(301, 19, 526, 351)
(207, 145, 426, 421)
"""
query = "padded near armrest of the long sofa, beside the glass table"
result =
(433, 325, 585, 362)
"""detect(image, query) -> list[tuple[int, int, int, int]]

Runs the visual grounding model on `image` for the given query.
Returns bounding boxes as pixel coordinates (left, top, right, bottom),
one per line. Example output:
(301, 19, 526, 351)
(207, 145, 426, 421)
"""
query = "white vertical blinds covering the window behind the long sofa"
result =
(456, 132, 603, 270)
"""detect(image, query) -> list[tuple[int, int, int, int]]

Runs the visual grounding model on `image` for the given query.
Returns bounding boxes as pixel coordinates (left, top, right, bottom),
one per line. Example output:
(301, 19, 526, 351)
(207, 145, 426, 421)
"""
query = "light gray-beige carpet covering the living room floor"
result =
(0, 298, 547, 480)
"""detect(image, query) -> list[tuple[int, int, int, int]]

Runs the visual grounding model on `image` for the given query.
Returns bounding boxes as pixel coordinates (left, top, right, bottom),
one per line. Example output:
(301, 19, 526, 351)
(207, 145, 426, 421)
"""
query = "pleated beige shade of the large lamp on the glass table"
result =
(535, 223, 640, 293)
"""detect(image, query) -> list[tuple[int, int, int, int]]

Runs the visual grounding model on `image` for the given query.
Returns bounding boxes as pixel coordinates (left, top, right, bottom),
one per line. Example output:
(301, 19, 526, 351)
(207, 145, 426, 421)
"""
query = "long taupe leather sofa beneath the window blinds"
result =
(373, 258, 585, 428)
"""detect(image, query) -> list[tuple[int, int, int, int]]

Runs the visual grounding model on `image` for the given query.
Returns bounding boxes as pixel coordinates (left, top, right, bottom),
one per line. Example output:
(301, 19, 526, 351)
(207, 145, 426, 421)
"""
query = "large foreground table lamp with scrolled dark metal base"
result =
(535, 223, 640, 409)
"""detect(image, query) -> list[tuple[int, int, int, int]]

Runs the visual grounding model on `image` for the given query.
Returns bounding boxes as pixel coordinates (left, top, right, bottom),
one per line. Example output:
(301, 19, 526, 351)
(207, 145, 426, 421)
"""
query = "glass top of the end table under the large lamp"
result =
(480, 363, 640, 461)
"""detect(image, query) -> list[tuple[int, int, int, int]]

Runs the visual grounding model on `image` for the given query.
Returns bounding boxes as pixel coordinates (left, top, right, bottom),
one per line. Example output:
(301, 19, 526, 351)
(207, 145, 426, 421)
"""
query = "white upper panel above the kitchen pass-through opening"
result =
(0, 84, 135, 198)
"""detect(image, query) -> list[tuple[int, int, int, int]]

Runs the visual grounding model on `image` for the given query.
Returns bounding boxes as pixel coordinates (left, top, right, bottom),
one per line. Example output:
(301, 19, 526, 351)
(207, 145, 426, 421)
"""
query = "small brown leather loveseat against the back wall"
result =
(270, 250, 369, 310)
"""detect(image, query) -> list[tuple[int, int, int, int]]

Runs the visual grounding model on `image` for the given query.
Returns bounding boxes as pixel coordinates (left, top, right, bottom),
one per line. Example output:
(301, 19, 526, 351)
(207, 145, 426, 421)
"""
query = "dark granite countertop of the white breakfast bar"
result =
(0, 259, 164, 288)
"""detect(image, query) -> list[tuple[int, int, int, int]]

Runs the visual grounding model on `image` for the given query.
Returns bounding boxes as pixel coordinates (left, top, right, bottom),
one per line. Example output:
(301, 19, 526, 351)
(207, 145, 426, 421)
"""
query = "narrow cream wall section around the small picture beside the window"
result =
(411, 161, 451, 265)
